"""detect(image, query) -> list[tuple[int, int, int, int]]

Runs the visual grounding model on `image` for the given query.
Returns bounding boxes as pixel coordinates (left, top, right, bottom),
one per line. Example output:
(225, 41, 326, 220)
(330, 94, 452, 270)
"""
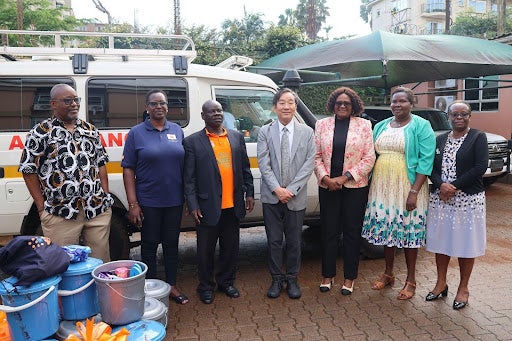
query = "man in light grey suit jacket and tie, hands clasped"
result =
(257, 88, 315, 298)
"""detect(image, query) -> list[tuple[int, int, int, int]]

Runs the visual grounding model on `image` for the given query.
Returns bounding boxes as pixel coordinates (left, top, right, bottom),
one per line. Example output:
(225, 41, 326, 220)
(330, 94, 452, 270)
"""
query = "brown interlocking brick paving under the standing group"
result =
(155, 183, 512, 341)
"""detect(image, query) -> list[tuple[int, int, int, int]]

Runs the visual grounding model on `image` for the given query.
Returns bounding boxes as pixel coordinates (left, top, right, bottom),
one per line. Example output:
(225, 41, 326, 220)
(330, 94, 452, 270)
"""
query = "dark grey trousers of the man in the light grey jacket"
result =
(263, 203, 306, 278)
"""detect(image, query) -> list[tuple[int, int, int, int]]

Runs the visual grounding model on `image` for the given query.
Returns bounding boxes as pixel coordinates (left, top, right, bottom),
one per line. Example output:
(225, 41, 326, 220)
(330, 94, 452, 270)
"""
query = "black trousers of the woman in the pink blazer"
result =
(318, 186, 369, 279)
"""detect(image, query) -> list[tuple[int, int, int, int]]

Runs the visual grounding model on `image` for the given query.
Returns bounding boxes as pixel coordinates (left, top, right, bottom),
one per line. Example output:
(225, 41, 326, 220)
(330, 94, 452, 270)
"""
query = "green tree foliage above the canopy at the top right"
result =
(450, 11, 512, 38)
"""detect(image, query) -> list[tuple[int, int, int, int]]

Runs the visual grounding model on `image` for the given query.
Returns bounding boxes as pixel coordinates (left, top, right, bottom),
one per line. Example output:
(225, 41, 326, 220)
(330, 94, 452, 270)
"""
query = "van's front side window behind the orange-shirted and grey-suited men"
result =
(215, 88, 277, 142)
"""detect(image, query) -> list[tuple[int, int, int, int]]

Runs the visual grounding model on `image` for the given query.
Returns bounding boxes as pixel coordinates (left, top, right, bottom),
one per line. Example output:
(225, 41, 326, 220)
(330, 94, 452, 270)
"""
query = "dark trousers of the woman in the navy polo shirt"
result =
(140, 205, 183, 285)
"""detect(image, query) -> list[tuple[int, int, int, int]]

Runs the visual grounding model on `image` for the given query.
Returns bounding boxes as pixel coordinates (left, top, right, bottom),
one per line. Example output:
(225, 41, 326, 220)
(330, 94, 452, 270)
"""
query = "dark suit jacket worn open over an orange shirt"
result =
(183, 129, 254, 226)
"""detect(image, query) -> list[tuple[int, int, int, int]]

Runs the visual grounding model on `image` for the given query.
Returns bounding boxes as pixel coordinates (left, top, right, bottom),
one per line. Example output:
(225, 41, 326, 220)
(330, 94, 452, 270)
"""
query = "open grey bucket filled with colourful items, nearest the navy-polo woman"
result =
(92, 260, 148, 325)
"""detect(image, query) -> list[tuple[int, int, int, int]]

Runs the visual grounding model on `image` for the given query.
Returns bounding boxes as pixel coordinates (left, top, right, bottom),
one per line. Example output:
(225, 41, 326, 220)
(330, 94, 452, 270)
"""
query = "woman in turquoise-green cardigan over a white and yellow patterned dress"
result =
(362, 87, 436, 300)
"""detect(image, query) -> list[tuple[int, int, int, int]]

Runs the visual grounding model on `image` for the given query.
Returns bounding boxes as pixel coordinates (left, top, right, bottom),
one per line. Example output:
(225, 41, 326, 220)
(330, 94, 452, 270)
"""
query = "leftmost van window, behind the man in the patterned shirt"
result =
(0, 77, 75, 131)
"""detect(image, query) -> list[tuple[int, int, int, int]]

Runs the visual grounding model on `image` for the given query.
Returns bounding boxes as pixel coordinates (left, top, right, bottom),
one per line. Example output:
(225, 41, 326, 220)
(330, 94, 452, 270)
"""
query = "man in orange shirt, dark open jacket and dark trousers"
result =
(183, 100, 254, 304)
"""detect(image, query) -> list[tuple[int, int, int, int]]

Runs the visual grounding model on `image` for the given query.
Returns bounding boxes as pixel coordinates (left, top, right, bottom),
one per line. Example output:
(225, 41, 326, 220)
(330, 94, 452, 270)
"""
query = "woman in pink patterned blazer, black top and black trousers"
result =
(315, 87, 375, 295)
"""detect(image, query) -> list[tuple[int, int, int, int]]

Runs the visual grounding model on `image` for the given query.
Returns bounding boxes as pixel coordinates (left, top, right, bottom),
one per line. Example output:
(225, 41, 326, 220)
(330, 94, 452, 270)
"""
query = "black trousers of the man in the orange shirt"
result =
(197, 208, 240, 292)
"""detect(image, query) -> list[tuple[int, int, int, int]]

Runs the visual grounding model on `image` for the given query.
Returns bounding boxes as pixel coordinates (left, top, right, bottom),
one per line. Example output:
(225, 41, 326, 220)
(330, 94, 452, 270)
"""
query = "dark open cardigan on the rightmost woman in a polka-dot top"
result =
(430, 129, 489, 194)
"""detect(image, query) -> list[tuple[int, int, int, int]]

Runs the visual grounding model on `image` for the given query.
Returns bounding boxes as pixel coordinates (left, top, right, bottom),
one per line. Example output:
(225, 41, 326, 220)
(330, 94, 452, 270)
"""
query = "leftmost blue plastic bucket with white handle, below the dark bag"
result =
(0, 276, 61, 341)
